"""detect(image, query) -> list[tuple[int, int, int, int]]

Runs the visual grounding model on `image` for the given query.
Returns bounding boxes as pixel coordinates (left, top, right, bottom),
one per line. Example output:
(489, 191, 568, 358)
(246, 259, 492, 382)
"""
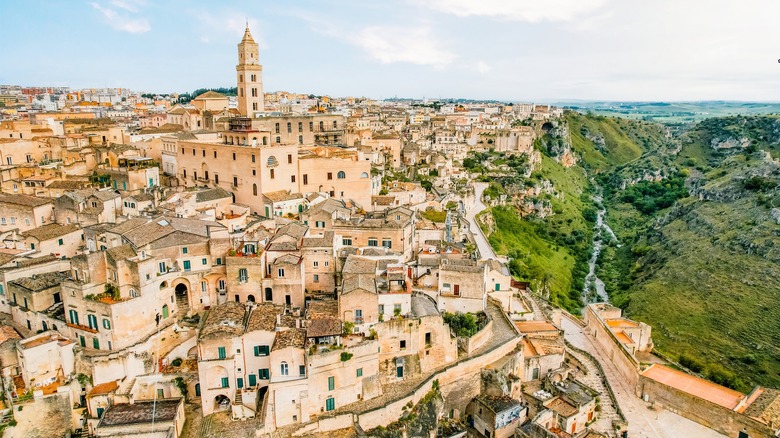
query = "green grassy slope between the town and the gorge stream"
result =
(478, 112, 666, 313)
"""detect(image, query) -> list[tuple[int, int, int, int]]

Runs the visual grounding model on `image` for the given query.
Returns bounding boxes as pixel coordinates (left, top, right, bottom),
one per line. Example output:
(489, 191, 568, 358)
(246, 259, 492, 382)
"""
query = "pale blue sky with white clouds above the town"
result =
(0, 0, 780, 101)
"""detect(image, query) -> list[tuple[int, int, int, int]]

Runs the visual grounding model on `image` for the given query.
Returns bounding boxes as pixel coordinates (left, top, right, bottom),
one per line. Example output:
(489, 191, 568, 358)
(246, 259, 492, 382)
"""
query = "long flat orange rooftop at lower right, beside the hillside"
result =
(642, 364, 745, 409)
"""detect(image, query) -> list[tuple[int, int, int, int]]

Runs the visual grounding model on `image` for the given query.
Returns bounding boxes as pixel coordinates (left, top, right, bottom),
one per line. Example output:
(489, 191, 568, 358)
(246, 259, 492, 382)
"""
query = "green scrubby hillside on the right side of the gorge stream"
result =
(598, 117, 780, 391)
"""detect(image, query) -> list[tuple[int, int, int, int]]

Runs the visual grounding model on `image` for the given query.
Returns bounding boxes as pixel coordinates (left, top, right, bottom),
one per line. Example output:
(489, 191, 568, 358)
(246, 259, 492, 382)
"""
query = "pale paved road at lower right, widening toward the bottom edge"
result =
(561, 317, 725, 438)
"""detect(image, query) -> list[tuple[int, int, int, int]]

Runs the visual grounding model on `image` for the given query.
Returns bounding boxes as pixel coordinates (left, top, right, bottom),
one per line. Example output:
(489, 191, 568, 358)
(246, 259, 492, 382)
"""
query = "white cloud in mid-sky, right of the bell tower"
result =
(348, 26, 456, 67)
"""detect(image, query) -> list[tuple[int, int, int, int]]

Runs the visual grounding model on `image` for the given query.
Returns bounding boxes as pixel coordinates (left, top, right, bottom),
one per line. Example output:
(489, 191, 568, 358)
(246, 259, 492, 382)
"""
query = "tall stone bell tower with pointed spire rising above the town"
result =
(236, 23, 265, 117)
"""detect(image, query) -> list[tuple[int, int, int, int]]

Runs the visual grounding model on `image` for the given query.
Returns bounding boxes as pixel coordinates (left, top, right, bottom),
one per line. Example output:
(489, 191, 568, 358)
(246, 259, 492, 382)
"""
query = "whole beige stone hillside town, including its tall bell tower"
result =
(0, 26, 780, 438)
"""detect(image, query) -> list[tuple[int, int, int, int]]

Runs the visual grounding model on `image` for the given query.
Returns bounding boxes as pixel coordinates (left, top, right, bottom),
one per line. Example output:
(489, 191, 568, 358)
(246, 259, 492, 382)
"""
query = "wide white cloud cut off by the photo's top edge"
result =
(412, 0, 607, 23)
